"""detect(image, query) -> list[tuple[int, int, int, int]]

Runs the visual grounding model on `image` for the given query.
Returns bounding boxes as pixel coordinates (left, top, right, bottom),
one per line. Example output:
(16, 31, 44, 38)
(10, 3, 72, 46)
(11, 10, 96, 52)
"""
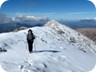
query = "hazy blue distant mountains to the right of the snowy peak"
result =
(59, 19, 96, 29)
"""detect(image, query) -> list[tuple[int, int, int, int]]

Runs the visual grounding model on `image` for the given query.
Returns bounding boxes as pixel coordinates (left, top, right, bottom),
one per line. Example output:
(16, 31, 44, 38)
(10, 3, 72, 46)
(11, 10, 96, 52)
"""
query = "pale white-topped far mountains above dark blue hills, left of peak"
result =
(12, 16, 49, 24)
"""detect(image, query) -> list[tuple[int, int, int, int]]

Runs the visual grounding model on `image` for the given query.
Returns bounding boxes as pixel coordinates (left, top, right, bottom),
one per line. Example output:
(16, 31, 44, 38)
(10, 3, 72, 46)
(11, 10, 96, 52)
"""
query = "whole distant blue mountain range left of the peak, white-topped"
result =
(0, 16, 49, 33)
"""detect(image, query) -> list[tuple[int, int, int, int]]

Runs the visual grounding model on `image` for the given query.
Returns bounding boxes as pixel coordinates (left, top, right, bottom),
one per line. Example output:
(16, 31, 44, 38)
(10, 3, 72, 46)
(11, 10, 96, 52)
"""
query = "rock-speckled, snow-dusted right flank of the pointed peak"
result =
(44, 20, 96, 54)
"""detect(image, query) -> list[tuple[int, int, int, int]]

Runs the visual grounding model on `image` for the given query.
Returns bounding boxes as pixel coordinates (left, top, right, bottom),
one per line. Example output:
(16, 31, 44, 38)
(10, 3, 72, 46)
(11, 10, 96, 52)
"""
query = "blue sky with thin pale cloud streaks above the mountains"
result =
(0, 0, 96, 20)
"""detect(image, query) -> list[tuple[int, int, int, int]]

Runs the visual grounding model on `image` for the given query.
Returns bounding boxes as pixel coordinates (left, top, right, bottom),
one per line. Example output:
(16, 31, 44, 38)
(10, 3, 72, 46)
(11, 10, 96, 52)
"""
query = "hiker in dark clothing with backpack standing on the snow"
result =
(27, 29, 35, 53)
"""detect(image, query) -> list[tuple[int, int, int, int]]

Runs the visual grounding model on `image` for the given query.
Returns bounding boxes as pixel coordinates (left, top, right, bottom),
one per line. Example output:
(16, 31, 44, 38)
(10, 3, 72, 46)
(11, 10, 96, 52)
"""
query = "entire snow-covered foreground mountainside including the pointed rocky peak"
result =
(0, 21, 96, 72)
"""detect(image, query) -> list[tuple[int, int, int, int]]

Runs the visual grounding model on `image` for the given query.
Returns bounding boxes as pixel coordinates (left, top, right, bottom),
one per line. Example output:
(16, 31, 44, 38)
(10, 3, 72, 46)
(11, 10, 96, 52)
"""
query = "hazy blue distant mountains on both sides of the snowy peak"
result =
(0, 15, 96, 33)
